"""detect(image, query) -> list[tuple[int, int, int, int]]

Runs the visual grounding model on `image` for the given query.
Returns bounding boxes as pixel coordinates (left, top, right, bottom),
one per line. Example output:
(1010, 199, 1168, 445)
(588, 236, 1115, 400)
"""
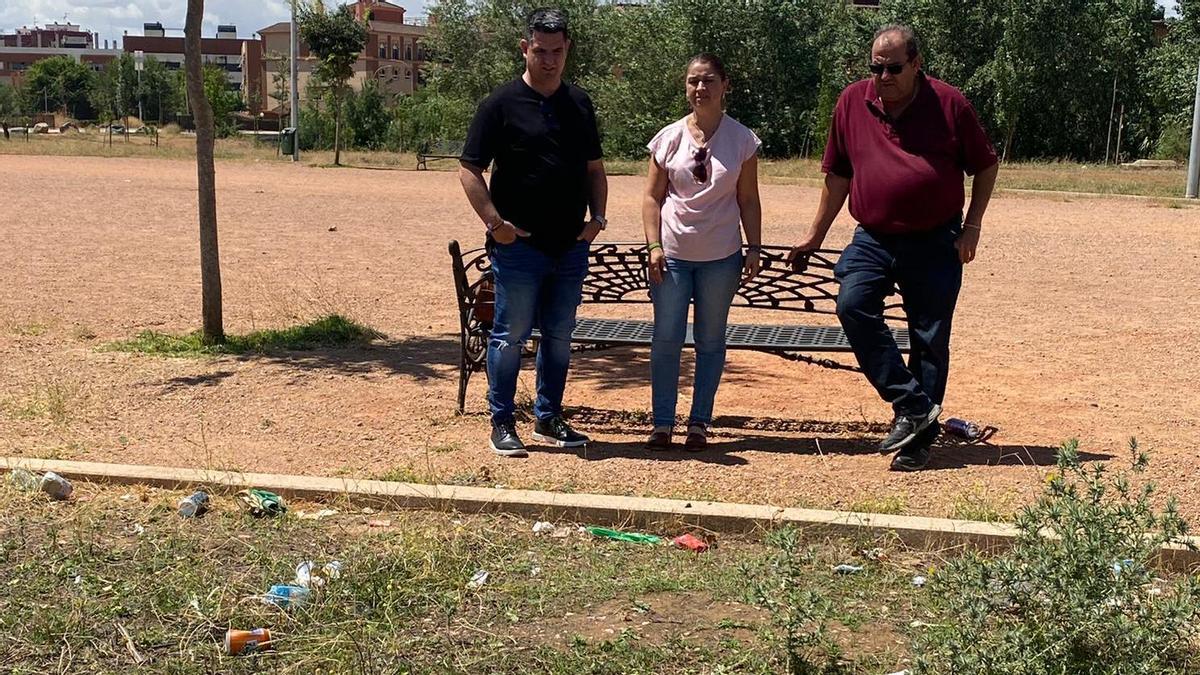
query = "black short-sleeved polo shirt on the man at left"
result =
(461, 78, 602, 255)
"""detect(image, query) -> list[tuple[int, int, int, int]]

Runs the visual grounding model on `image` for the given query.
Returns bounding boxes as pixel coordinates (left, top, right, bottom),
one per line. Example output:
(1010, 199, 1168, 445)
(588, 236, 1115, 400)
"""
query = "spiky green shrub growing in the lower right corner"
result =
(914, 441, 1200, 675)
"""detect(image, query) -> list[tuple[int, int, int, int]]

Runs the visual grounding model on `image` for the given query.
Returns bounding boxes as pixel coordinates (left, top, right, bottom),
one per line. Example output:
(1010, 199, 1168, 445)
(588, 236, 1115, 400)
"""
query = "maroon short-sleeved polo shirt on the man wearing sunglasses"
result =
(821, 73, 996, 234)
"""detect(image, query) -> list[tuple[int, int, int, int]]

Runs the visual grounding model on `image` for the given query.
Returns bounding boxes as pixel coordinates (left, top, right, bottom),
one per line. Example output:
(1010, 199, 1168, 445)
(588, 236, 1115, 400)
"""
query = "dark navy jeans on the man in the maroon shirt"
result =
(834, 219, 962, 416)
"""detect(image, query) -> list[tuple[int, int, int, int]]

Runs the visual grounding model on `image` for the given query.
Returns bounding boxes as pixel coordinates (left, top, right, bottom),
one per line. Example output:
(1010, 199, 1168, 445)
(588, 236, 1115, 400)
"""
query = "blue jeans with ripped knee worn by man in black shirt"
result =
(487, 239, 588, 424)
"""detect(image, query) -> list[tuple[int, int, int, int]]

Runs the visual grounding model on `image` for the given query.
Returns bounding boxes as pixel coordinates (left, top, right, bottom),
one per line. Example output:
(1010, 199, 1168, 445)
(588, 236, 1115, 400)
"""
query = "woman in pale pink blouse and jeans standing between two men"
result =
(642, 54, 762, 452)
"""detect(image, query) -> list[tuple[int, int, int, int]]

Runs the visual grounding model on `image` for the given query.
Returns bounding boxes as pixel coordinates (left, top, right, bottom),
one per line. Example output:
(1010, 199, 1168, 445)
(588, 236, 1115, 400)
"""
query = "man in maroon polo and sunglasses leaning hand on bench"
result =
(791, 25, 998, 471)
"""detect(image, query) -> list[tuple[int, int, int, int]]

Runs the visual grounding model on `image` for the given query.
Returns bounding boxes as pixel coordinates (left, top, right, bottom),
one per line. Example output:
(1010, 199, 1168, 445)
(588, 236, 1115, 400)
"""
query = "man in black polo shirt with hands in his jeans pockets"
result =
(458, 10, 608, 456)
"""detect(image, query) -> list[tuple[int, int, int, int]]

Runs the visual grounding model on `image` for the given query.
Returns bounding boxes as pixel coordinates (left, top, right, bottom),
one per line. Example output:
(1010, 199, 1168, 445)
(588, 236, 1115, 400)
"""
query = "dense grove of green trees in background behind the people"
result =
(0, 0, 1200, 161)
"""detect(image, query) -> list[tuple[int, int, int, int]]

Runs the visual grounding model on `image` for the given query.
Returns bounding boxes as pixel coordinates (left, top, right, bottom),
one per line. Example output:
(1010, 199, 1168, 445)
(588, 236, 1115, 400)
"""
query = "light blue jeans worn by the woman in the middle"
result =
(650, 251, 742, 426)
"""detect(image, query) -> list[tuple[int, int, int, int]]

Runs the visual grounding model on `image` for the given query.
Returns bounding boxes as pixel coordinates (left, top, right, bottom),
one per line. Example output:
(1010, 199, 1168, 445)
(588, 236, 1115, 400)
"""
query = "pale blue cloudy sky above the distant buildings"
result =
(0, 0, 1175, 48)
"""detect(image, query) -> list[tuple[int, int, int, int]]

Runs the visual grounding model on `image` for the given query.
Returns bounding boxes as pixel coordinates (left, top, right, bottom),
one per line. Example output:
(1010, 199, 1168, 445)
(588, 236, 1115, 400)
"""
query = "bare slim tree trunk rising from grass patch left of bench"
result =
(184, 0, 224, 345)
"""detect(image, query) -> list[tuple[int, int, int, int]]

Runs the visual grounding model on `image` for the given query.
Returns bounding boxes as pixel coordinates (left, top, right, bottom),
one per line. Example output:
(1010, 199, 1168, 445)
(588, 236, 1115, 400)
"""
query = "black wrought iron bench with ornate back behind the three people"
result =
(450, 241, 910, 413)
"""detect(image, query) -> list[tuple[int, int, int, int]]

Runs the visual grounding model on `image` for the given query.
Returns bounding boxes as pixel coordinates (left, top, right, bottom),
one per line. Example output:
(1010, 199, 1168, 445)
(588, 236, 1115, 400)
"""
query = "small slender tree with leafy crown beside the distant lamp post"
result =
(296, 0, 367, 166)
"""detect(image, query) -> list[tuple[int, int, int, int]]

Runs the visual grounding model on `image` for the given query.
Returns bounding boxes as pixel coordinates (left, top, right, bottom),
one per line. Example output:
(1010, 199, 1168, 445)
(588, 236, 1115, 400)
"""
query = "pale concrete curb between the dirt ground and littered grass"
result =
(0, 458, 1200, 569)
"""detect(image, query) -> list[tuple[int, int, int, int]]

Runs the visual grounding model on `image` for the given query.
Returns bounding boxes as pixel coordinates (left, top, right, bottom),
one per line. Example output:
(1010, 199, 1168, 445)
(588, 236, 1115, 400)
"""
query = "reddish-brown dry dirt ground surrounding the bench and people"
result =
(0, 156, 1200, 516)
